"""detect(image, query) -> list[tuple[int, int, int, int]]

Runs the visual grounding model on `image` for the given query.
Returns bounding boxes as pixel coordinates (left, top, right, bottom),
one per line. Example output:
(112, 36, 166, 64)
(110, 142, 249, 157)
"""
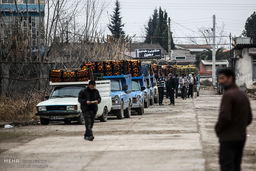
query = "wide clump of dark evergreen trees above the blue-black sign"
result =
(145, 8, 175, 51)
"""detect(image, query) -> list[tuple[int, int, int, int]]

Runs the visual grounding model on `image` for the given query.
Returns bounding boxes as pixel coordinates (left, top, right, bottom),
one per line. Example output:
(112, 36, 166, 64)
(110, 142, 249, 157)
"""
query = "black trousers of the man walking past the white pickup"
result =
(84, 110, 97, 137)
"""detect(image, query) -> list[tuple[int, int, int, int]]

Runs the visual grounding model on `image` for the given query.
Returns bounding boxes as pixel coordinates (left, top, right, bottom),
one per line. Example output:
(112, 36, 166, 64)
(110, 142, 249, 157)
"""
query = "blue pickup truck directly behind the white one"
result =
(103, 75, 132, 119)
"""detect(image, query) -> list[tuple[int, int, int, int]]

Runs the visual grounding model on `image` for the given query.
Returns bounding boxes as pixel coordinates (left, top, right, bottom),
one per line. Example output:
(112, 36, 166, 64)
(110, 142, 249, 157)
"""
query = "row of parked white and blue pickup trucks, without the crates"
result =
(36, 62, 159, 125)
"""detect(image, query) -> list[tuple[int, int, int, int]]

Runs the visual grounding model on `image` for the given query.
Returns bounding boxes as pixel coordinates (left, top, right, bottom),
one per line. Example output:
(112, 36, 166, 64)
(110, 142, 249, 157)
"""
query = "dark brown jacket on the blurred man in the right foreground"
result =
(215, 84, 252, 142)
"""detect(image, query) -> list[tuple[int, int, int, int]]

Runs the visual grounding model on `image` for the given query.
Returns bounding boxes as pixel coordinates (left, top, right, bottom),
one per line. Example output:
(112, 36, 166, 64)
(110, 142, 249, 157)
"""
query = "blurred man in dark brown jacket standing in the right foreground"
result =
(215, 69, 252, 171)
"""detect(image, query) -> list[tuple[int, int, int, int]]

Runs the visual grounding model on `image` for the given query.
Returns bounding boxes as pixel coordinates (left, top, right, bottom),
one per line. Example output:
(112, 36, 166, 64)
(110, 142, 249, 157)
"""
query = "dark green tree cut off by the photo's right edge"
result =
(243, 12, 256, 43)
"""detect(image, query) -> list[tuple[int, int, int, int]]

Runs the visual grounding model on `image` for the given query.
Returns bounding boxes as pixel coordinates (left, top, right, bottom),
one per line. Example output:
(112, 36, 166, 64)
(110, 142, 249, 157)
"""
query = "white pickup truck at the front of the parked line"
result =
(36, 81, 112, 125)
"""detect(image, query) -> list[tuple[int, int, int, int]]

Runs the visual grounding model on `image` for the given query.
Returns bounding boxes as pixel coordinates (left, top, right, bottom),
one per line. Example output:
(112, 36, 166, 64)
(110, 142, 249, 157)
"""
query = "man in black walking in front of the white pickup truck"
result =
(78, 81, 101, 141)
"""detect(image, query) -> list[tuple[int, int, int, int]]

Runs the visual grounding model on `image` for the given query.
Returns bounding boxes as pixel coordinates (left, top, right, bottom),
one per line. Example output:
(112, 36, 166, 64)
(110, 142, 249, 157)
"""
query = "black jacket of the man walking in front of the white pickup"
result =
(78, 87, 101, 113)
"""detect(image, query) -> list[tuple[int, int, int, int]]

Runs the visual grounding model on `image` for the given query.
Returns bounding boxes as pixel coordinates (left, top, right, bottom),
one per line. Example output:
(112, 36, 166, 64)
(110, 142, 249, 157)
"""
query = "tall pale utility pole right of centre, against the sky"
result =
(212, 15, 216, 87)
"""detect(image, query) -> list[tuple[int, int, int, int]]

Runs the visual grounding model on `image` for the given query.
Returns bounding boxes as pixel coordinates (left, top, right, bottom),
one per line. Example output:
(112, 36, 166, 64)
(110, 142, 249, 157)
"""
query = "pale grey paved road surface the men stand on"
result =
(0, 91, 256, 171)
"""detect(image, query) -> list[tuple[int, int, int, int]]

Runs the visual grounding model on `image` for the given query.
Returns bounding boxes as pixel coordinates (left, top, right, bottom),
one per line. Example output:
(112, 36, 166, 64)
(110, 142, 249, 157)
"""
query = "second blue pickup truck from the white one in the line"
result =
(132, 76, 146, 115)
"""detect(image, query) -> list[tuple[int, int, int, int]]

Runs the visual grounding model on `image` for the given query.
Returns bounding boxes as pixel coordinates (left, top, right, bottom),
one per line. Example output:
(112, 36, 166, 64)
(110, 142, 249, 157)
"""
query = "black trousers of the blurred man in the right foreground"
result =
(219, 141, 245, 171)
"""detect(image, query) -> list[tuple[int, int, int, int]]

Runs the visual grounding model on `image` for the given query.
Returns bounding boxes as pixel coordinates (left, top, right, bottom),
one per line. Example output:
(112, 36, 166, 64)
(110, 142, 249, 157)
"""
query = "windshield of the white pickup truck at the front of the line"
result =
(51, 86, 84, 98)
